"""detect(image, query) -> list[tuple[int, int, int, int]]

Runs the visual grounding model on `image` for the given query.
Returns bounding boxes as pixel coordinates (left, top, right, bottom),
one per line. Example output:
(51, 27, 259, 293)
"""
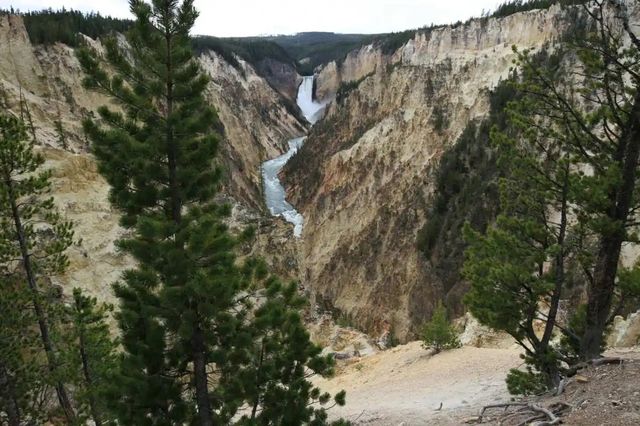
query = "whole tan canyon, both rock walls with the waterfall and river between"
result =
(0, 5, 638, 342)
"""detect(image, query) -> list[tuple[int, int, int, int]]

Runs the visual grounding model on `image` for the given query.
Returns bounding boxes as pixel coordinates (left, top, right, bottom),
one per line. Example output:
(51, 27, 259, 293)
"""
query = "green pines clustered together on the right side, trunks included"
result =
(464, 0, 640, 391)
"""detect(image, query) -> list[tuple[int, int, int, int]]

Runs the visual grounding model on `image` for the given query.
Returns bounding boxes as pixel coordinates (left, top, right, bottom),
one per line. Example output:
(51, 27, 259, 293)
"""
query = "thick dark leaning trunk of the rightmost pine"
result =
(580, 93, 640, 360)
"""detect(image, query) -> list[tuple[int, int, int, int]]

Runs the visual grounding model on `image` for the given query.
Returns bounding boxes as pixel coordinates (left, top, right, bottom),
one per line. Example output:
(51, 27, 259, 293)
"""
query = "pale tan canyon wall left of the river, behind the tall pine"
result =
(0, 15, 306, 301)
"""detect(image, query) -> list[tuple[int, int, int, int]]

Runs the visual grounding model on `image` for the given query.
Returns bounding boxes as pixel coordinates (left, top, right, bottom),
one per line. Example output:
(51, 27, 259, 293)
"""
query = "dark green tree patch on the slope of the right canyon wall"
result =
(416, 81, 515, 310)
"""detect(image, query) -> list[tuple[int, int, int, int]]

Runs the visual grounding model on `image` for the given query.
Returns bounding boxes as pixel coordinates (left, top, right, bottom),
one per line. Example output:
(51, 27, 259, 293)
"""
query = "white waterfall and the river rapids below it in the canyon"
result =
(262, 75, 325, 237)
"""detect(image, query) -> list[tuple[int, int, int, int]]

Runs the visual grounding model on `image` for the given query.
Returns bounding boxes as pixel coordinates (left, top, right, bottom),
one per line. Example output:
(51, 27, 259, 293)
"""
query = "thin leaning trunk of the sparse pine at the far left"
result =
(5, 177, 75, 423)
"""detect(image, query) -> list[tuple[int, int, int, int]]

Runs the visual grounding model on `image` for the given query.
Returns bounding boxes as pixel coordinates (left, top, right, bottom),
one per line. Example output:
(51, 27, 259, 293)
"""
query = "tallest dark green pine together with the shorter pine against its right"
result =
(79, 0, 344, 425)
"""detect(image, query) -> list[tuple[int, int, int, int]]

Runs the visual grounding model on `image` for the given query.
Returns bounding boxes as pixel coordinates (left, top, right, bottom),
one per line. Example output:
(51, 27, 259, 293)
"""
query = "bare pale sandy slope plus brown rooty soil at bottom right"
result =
(316, 342, 640, 426)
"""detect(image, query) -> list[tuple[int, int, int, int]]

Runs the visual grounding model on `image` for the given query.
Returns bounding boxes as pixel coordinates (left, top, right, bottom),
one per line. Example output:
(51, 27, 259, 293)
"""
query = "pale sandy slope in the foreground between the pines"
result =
(316, 342, 522, 426)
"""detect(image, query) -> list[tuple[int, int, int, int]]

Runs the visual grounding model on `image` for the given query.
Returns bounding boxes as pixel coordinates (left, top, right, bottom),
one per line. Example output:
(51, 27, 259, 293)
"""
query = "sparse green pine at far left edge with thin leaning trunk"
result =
(0, 114, 74, 421)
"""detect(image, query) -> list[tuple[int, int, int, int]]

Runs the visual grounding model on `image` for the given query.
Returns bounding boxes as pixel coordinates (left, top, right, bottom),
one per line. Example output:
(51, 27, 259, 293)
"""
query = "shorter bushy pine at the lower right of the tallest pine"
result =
(239, 277, 345, 425)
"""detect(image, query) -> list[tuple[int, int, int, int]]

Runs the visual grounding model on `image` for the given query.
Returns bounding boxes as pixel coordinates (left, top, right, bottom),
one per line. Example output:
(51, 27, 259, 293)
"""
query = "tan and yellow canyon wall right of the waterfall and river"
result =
(284, 7, 562, 340)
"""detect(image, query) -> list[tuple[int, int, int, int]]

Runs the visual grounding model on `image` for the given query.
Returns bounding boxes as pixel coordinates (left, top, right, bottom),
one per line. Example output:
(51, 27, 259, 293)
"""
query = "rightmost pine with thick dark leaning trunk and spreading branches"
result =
(500, 0, 640, 359)
